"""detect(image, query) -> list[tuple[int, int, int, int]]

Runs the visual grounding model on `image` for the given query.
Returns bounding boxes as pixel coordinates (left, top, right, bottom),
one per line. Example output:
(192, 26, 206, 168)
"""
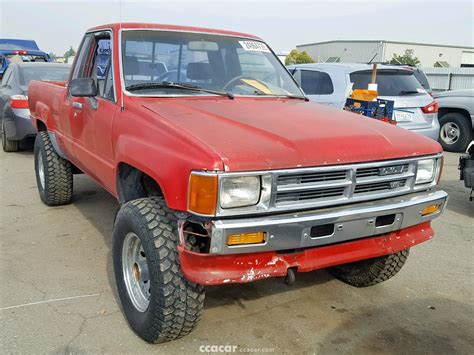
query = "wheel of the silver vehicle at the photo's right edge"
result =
(439, 112, 472, 152)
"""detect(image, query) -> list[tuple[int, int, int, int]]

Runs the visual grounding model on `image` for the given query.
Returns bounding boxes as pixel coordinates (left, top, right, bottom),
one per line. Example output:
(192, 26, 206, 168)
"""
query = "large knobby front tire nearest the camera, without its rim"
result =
(112, 197, 204, 343)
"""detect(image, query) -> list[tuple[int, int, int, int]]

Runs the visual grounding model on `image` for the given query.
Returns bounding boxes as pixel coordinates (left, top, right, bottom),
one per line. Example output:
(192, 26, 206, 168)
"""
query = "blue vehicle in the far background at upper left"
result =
(0, 38, 51, 79)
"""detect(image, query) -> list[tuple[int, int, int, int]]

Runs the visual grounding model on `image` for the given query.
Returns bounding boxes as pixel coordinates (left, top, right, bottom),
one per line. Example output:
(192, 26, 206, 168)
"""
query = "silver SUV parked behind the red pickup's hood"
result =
(288, 63, 439, 140)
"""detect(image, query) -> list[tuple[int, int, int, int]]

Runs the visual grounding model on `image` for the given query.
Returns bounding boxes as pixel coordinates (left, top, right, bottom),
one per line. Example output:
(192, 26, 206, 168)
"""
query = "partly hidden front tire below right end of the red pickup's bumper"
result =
(329, 249, 409, 287)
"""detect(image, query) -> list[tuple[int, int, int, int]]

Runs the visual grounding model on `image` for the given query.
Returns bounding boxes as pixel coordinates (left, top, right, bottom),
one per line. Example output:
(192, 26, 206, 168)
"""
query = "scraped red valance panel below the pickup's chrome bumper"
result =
(179, 222, 434, 285)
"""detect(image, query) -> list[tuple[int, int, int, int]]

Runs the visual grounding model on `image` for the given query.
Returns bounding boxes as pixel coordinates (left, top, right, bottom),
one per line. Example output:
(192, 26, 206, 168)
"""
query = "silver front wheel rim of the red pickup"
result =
(122, 233, 150, 312)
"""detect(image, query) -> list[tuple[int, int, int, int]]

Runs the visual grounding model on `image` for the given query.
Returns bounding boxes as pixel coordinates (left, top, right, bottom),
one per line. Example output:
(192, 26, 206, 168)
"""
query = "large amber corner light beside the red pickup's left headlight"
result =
(188, 174, 217, 215)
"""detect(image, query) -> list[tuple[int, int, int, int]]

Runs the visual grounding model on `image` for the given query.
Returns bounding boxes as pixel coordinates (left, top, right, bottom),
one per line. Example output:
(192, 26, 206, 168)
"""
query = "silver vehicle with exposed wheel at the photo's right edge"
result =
(434, 89, 474, 152)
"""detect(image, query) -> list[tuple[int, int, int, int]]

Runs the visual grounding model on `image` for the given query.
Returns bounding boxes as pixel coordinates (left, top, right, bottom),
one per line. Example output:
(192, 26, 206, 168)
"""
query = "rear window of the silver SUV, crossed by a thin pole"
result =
(350, 69, 426, 96)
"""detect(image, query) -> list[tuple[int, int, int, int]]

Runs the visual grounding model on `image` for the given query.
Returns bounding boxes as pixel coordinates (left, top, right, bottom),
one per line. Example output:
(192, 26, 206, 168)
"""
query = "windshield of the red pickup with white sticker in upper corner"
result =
(122, 30, 302, 96)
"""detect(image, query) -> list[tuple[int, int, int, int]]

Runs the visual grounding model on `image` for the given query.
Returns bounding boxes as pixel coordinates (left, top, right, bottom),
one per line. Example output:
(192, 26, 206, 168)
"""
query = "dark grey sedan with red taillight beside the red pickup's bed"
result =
(0, 63, 71, 152)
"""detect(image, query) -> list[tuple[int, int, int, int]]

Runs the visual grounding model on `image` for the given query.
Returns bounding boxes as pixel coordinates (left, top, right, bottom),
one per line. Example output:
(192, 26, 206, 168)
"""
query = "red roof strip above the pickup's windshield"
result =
(87, 22, 261, 40)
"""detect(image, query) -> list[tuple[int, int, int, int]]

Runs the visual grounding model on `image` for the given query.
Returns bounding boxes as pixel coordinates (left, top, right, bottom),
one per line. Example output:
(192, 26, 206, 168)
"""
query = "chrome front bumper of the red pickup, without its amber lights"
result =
(210, 191, 448, 254)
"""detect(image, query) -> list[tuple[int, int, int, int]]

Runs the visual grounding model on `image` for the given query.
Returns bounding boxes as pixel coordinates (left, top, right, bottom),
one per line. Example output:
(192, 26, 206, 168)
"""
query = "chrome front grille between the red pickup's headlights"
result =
(272, 160, 416, 208)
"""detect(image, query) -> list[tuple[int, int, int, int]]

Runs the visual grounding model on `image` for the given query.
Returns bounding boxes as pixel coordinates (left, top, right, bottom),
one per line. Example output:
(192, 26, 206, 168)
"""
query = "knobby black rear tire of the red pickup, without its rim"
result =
(34, 132, 73, 206)
